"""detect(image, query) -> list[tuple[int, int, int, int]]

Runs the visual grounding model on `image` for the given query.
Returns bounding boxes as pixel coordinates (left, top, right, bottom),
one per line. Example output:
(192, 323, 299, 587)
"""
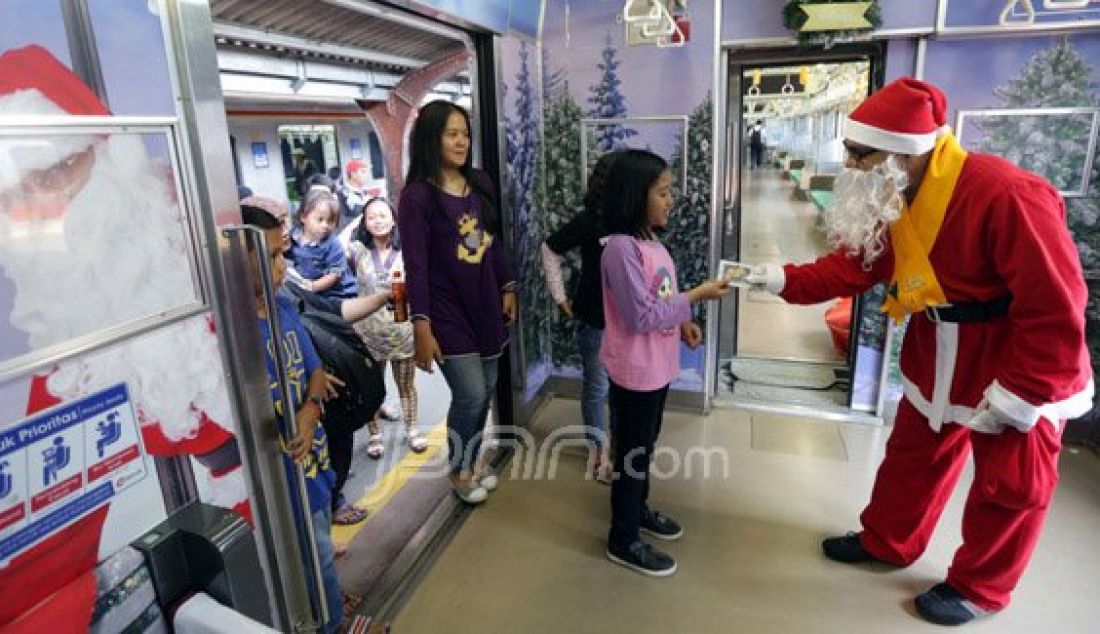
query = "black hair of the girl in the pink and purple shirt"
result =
(603, 150, 669, 238)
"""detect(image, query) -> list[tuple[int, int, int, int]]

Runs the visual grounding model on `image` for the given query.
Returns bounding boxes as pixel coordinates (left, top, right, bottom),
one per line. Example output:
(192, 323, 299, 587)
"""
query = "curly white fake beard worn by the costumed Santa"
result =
(823, 155, 909, 270)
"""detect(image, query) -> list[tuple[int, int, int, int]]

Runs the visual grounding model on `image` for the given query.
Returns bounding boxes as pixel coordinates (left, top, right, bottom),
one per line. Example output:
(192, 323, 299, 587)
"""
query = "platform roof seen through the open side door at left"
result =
(210, 0, 471, 109)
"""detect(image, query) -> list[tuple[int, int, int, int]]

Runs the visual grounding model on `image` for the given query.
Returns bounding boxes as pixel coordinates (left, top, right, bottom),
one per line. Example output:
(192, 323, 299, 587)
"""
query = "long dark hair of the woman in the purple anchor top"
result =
(405, 99, 501, 234)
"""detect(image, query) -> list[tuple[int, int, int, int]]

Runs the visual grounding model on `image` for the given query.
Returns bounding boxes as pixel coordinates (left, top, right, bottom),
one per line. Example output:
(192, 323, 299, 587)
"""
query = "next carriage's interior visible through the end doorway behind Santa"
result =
(727, 62, 869, 364)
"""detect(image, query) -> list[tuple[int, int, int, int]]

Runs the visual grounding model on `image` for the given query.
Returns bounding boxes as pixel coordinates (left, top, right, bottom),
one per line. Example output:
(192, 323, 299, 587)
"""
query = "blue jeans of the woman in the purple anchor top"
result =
(440, 354, 498, 474)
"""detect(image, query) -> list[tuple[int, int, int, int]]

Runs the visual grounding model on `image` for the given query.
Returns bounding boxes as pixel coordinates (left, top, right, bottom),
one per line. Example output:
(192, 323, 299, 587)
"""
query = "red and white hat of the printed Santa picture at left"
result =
(0, 45, 109, 192)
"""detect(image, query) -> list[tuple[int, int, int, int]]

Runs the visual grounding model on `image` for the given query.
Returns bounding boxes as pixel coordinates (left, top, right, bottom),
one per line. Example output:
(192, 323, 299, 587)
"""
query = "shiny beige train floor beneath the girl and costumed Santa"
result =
(394, 398, 1100, 634)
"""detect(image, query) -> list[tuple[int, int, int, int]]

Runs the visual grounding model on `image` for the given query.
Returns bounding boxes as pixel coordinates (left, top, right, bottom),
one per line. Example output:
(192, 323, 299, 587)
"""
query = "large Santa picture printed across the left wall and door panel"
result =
(0, 46, 248, 632)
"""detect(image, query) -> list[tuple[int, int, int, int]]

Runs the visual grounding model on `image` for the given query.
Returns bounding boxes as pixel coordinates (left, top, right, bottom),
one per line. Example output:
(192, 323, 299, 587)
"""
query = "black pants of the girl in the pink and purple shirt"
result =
(607, 381, 669, 548)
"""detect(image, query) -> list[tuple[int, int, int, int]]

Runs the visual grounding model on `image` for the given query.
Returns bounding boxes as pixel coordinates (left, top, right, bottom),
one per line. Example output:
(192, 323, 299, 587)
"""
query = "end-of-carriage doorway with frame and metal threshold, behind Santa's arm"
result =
(716, 47, 884, 414)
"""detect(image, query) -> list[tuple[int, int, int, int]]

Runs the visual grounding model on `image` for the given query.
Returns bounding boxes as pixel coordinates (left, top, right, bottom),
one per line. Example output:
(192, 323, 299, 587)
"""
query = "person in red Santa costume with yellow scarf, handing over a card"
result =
(751, 78, 1092, 625)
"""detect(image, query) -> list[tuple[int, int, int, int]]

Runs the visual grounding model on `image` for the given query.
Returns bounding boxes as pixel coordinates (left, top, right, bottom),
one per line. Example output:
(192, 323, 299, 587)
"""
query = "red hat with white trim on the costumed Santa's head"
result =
(844, 77, 949, 155)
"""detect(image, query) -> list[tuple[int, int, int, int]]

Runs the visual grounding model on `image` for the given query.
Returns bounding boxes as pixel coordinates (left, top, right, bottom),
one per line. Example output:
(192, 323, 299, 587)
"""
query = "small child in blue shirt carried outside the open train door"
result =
(290, 188, 359, 299)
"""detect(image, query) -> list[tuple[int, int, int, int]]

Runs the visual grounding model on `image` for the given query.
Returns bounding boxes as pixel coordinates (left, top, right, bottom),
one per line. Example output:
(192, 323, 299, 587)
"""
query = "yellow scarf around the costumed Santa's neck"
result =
(882, 132, 966, 324)
